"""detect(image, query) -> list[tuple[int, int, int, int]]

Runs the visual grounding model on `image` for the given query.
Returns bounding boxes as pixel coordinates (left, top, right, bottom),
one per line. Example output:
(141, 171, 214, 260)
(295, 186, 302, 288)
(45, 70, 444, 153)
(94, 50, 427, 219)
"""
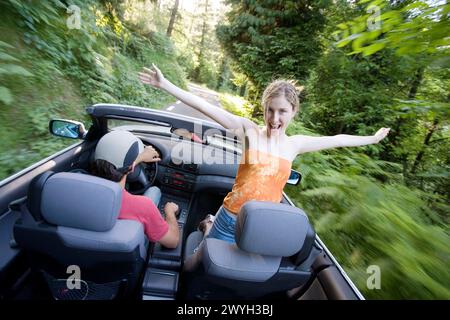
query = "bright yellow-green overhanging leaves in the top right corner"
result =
(335, 0, 450, 62)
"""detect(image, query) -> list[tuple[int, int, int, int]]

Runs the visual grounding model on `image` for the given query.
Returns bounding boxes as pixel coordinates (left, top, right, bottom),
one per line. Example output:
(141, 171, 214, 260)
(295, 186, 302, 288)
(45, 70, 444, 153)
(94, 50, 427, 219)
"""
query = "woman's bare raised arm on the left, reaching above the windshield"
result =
(139, 64, 258, 131)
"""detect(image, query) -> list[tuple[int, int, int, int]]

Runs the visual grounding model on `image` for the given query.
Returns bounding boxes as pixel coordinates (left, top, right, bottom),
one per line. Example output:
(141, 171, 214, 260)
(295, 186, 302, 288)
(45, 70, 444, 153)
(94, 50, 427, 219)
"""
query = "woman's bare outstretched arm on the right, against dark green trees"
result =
(292, 128, 390, 154)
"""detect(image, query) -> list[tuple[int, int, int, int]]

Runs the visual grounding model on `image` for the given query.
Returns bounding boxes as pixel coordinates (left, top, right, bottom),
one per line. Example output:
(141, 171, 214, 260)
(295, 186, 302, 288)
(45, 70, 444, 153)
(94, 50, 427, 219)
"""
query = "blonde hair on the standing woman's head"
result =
(262, 79, 303, 111)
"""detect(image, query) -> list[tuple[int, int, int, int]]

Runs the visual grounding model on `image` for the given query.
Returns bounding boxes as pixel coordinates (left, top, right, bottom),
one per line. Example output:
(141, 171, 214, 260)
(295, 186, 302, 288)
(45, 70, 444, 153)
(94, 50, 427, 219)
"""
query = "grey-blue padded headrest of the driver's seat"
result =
(40, 172, 122, 231)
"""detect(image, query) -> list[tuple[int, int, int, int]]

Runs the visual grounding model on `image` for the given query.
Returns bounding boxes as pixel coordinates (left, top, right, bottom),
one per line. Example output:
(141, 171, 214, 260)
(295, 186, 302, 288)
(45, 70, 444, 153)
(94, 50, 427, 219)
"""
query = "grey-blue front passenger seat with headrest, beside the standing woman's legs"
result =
(184, 201, 317, 299)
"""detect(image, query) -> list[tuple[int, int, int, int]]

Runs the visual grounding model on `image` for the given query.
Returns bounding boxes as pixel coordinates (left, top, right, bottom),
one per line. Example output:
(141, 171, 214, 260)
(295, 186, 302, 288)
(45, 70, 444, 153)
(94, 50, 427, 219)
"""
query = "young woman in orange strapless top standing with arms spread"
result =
(139, 64, 390, 243)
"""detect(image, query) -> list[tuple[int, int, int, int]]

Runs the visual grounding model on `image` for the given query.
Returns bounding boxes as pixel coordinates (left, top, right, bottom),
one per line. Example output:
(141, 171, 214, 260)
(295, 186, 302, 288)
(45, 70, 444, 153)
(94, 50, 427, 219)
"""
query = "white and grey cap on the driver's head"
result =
(94, 130, 144, 169)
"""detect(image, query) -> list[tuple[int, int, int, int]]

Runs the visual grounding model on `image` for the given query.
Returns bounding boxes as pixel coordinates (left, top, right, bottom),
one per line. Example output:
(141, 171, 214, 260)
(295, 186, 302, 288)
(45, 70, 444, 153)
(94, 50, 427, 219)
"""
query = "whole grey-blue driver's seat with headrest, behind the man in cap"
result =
(14, 171, 148, 299)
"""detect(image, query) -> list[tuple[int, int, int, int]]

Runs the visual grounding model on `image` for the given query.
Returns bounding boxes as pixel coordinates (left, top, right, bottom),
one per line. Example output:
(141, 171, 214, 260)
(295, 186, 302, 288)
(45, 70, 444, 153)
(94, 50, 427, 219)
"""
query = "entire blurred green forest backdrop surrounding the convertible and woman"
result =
(0, 0, 450, 299)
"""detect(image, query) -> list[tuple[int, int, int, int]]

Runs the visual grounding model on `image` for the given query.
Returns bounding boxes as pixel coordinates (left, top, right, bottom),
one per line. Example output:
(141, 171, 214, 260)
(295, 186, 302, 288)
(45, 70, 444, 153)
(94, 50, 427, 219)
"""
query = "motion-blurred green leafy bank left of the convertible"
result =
(0, 0, 185, 179)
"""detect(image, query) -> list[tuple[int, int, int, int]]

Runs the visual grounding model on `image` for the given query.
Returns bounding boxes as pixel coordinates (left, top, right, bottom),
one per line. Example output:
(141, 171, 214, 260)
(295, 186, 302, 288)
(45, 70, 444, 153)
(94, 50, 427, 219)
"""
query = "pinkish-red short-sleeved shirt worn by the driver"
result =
(119, 190, 169, 242)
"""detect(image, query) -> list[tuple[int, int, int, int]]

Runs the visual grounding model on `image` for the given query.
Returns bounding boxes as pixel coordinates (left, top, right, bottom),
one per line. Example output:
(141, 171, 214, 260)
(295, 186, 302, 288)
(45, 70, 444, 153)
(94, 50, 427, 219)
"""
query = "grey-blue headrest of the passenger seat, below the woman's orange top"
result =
(235, 201, 310, 257)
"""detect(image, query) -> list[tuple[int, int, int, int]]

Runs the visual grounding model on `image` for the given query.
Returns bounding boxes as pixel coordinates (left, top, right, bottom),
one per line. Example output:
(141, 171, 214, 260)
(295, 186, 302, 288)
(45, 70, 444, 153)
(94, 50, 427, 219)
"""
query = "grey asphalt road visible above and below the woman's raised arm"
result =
(164, 83, 220, 122)
